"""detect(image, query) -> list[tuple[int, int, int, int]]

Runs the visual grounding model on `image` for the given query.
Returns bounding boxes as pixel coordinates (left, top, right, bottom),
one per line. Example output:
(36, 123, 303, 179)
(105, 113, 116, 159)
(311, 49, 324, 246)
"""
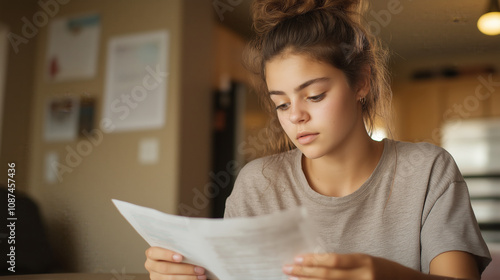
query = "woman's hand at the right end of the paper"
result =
(283, 254, 382, 280)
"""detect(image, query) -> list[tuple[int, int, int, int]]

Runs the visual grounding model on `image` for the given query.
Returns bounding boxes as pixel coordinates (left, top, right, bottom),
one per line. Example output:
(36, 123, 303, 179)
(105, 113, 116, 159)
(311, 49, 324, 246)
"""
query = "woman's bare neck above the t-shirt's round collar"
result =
(302, 135, 384, 197)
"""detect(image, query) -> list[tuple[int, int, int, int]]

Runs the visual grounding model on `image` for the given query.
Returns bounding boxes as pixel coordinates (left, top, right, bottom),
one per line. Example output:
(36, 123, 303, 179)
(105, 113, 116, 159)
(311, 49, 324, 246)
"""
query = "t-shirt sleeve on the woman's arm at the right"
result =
(421, 155, 491, 273)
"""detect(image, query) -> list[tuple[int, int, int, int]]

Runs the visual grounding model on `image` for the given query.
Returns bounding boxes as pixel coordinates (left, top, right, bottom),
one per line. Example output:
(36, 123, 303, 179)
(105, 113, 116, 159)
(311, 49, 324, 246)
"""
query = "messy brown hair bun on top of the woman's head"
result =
(252, 0, 361, 36)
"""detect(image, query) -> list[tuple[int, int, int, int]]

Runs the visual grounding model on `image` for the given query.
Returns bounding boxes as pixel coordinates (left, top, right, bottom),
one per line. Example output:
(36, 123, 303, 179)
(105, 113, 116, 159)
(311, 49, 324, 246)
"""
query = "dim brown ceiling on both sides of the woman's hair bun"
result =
(221, 0, 500, 61)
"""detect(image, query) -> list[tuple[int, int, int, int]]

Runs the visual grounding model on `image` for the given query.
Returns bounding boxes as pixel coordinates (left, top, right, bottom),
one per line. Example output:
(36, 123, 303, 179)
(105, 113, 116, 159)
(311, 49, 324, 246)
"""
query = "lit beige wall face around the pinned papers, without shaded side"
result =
(29, 0, 182, 272)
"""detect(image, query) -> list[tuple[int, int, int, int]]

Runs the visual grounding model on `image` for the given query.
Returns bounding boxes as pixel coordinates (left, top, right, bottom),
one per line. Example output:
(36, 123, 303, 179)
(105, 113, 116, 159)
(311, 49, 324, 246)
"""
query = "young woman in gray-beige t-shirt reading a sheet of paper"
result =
(146, 0, 491, 280)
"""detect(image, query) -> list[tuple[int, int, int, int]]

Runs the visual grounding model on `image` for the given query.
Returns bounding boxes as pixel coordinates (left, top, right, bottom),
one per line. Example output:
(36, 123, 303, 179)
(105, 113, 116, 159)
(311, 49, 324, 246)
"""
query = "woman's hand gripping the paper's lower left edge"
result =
(144, 247, 207, 280)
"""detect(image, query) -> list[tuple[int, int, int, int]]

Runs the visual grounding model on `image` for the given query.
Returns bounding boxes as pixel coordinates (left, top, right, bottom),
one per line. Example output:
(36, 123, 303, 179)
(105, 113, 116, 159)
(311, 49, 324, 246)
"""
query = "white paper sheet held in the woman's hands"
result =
(113, 199, 318, 280)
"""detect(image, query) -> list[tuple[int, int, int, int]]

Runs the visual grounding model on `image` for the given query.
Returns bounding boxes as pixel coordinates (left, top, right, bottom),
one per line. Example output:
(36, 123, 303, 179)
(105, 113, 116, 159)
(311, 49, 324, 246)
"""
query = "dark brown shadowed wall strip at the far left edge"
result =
(0, 1, 38, 191)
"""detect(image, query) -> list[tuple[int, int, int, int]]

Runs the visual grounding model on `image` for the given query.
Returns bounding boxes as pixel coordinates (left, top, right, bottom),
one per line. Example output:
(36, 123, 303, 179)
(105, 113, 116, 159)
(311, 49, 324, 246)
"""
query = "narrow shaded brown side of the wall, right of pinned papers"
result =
(177, 0, 215, 217)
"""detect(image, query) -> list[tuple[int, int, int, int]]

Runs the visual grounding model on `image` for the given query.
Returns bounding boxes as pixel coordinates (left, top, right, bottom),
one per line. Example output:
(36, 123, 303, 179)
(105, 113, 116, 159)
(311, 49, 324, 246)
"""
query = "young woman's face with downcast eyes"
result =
(265, 54, 366, 159)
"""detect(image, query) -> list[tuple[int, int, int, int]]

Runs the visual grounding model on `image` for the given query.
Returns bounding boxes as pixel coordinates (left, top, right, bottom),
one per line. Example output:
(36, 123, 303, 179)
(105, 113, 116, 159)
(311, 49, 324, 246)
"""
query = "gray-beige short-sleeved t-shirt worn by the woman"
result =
(224, 139, 491, 273)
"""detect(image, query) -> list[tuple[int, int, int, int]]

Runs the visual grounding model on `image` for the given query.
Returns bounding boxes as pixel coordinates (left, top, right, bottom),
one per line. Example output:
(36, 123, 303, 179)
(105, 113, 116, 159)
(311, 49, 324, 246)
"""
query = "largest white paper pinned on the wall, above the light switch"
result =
(102, 30, 169, 132)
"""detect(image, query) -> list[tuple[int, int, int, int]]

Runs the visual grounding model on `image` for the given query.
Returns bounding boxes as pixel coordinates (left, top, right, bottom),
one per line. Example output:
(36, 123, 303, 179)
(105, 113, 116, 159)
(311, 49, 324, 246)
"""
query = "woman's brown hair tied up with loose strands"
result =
(245, 0, 392, 154)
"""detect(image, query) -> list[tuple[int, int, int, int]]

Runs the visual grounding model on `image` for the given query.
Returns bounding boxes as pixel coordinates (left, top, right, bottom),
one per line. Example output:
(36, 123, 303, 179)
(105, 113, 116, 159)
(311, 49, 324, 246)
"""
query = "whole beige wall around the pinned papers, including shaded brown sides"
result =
(0, 0, 214, 273)
